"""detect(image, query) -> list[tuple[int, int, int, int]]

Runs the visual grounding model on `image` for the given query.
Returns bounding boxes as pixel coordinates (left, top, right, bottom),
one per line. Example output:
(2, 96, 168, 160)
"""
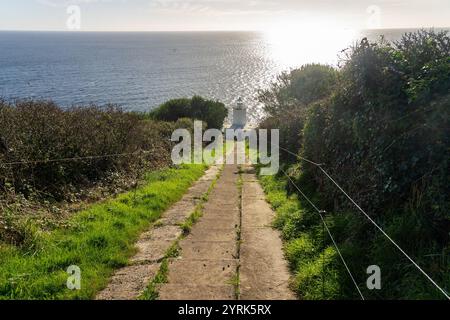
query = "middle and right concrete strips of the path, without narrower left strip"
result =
(160, 161, 295, 300)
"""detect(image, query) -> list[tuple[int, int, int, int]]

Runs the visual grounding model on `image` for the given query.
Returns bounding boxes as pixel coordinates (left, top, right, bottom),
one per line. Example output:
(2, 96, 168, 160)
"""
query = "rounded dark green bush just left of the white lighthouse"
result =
(150, 96, 228, 129)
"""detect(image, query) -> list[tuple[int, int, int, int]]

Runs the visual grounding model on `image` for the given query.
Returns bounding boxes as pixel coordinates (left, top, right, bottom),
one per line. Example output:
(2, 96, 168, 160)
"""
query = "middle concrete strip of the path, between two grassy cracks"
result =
(159, 165, 240, 300)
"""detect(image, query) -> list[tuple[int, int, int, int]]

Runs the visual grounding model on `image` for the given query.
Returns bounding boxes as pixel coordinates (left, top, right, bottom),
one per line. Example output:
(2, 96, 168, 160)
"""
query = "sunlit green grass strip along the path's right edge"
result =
(259, 172, 341, 300)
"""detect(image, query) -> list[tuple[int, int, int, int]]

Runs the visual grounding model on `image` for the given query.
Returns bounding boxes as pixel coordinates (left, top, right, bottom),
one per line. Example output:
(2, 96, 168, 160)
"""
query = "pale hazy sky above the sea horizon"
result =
(0, 0, 450, 31)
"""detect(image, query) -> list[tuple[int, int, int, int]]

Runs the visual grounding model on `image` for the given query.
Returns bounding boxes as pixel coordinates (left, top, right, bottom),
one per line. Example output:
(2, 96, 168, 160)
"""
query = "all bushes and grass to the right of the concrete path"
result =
(261, 30, 450, 299)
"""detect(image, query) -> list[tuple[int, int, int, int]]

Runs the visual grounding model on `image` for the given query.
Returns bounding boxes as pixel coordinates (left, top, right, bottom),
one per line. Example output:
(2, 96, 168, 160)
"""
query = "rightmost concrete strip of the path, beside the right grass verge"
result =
(239, 166, 295, 300)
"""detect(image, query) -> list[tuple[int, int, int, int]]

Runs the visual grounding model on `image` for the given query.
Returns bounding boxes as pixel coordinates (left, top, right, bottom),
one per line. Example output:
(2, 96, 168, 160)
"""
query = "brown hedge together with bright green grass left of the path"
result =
(0, 98, 223, 299)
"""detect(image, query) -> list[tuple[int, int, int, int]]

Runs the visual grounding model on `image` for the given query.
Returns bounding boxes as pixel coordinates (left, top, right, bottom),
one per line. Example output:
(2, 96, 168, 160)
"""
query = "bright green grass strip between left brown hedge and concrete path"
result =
(0, 165, 206, 299)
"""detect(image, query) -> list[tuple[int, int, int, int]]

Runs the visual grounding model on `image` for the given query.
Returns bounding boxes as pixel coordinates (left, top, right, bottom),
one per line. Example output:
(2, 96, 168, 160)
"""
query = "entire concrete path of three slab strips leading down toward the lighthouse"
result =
(97, 149, 295, 300)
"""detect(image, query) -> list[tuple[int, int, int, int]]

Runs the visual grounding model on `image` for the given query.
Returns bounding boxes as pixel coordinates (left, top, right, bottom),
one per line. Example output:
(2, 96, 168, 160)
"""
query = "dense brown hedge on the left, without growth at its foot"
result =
(0, 101, 192, 200)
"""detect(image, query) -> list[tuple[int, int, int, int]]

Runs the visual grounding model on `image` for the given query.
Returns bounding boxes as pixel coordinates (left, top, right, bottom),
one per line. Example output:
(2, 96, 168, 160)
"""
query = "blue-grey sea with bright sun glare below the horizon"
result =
(0, 30, 446, 122)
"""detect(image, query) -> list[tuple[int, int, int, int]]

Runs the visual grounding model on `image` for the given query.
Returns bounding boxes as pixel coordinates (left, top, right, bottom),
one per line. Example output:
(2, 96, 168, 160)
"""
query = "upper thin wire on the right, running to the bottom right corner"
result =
(275, 144, 450, 300)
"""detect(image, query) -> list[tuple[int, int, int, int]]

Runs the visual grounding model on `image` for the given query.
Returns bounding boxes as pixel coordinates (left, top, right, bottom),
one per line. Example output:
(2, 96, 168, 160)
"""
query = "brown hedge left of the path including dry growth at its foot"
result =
(0, 100, 207, 246)
